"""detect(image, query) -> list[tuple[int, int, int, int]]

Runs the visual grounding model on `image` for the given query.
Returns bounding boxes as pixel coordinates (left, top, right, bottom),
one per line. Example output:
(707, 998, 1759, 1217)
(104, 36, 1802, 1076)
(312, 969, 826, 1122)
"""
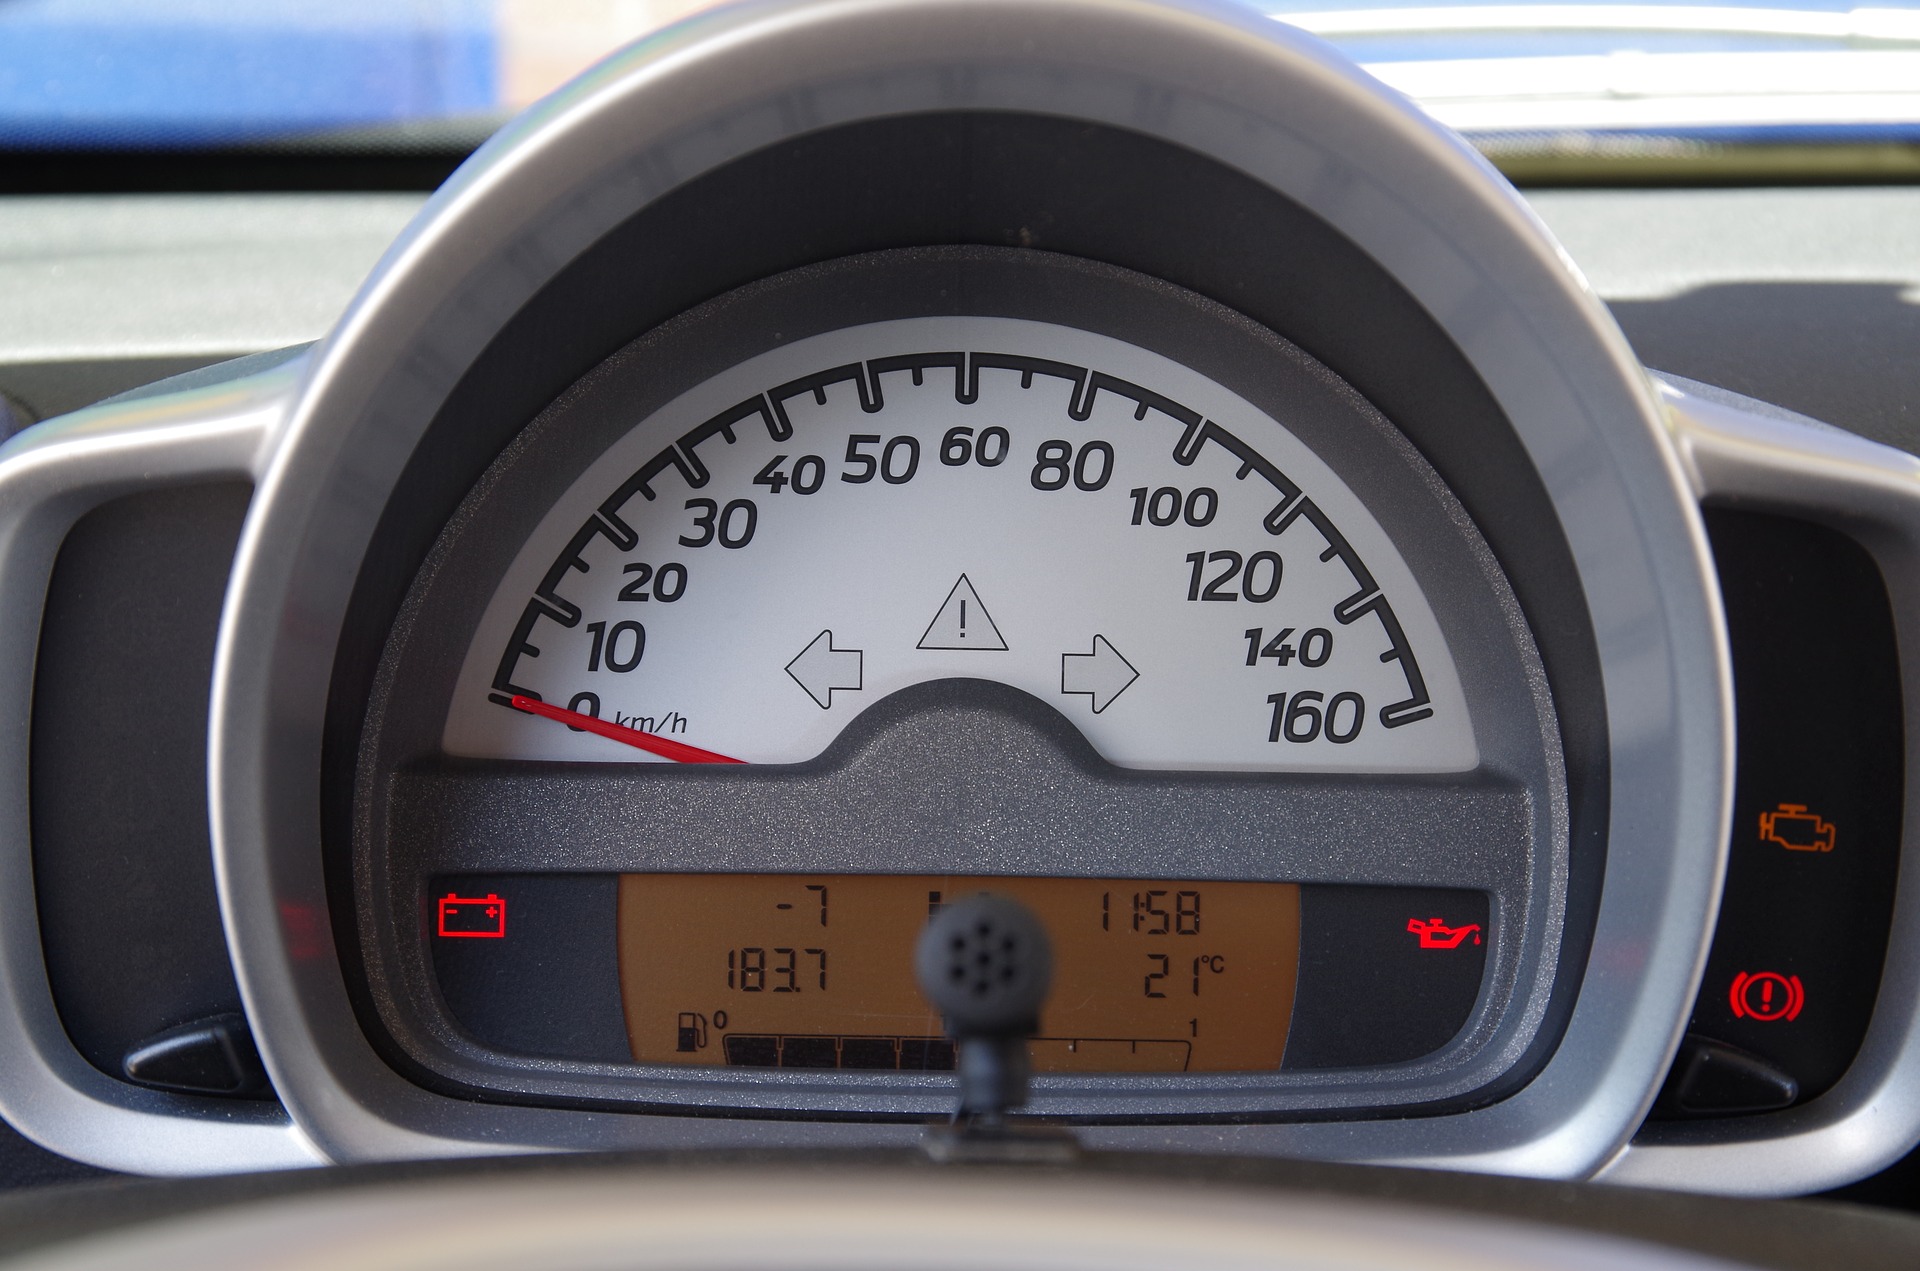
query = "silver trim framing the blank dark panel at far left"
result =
(0, 359, 319, 1173)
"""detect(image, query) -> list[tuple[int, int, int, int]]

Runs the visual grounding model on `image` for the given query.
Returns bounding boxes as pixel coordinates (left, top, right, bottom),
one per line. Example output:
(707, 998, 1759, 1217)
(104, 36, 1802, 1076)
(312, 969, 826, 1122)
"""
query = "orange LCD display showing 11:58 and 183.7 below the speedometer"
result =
(620, 874, 1300, 1073)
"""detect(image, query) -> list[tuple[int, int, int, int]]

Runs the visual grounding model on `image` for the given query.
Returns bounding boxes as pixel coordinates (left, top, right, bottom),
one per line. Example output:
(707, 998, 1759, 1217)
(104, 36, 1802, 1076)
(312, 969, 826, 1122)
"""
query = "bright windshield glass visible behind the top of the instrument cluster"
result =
(0, 0, 1920, 179)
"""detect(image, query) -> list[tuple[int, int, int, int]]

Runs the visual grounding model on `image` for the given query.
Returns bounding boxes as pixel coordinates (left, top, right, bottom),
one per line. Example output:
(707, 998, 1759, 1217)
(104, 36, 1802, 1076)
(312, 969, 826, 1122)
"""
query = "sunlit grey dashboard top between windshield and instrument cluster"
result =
(15, 186, 1920, 449)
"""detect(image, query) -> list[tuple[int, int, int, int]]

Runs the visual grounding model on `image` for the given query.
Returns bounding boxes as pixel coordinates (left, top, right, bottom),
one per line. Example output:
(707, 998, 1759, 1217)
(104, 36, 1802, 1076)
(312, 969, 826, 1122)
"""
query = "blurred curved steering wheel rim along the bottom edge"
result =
(0, 1150, 1920, 1271)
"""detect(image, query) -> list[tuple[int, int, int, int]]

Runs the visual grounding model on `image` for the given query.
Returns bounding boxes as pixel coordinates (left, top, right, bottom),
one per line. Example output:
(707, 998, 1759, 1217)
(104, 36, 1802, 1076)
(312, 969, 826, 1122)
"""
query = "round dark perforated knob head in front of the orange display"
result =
(914, 895, 1054, 1041)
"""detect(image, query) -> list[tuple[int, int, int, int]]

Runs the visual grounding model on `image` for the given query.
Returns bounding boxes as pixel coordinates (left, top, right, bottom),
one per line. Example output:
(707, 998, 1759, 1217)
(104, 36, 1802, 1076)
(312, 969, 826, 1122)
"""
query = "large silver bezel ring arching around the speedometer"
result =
(211, 0, 1732, 1177)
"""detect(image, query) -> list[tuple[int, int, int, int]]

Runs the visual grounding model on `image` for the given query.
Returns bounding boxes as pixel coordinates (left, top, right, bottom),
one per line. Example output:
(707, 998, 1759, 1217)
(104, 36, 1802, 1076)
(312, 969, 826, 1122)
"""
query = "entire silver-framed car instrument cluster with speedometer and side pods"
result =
(0, 0, 1920, 1192)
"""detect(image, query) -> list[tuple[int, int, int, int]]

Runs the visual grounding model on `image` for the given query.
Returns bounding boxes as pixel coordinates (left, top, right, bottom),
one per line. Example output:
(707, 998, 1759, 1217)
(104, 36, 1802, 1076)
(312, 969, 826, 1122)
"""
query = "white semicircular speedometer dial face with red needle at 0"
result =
(442, 317, 1478, 772)
